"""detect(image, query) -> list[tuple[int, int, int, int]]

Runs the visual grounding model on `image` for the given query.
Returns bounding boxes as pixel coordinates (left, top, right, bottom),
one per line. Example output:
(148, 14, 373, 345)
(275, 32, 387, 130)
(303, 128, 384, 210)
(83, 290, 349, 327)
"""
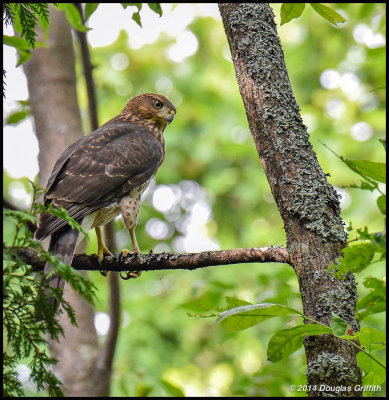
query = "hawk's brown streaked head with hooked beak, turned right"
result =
(121, 93, 176, 133)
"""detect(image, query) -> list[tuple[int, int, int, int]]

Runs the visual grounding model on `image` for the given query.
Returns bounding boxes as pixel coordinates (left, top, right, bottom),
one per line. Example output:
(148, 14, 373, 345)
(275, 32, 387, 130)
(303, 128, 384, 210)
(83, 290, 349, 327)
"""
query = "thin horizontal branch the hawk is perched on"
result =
(19, 246, 290, 272)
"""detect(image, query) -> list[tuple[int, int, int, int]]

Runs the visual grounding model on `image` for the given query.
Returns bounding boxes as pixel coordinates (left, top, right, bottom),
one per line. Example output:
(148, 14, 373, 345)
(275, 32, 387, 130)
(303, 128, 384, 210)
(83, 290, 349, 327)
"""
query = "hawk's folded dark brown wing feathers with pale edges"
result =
(35, 123, 163, 239)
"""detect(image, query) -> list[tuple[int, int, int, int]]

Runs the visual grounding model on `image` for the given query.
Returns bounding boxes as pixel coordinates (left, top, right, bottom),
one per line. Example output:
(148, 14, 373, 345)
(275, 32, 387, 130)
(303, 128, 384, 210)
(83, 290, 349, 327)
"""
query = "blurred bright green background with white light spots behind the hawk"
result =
(3, 3, 386, 397)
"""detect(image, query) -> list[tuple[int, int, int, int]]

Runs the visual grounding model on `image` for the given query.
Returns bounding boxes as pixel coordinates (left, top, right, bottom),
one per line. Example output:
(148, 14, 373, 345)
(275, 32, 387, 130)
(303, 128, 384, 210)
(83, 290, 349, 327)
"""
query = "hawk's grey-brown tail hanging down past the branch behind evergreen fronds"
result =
(44, 225, 79, 311)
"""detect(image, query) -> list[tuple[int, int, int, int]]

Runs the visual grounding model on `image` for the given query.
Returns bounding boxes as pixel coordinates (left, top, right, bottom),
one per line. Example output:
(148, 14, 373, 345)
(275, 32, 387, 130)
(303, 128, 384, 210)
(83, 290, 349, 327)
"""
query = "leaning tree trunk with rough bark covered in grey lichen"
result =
(219, 3, 361, 396)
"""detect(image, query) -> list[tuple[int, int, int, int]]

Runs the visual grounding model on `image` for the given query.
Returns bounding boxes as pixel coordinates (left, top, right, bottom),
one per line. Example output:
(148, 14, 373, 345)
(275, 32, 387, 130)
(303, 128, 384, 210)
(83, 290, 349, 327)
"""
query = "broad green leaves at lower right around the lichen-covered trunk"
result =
(209, 138, 386, 385)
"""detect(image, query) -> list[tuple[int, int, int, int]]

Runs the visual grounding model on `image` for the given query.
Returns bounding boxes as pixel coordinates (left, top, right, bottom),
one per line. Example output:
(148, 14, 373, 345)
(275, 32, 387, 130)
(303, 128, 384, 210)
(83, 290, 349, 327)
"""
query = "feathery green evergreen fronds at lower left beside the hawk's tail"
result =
(3, 185, 95, 397)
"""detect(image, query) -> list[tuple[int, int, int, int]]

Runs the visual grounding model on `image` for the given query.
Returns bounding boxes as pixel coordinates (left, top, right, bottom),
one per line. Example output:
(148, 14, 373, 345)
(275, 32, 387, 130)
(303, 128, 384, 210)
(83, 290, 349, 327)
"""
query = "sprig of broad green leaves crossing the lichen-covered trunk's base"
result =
(212, 296, 386, 385)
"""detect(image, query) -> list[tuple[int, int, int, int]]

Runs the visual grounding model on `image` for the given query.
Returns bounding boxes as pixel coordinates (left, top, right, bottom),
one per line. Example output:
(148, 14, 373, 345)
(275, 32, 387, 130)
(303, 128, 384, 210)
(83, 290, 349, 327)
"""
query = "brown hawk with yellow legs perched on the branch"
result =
(35, 93, 176, 303)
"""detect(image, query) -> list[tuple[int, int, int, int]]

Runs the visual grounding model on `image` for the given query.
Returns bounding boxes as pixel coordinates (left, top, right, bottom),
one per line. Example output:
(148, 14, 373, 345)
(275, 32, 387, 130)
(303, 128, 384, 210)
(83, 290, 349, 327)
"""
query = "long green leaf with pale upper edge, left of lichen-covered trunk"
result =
(216, 303, 303, 332)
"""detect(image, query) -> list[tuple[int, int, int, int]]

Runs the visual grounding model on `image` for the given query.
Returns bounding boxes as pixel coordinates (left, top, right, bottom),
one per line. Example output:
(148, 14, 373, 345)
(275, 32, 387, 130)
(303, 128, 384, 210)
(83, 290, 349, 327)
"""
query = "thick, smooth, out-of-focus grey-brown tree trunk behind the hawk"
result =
(24, 7, 116, 397)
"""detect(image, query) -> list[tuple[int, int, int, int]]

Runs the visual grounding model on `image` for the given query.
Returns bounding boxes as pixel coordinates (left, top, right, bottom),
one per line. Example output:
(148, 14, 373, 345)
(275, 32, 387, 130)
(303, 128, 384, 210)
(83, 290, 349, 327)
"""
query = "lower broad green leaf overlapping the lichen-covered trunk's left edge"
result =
(267, 324, 332, 362)
